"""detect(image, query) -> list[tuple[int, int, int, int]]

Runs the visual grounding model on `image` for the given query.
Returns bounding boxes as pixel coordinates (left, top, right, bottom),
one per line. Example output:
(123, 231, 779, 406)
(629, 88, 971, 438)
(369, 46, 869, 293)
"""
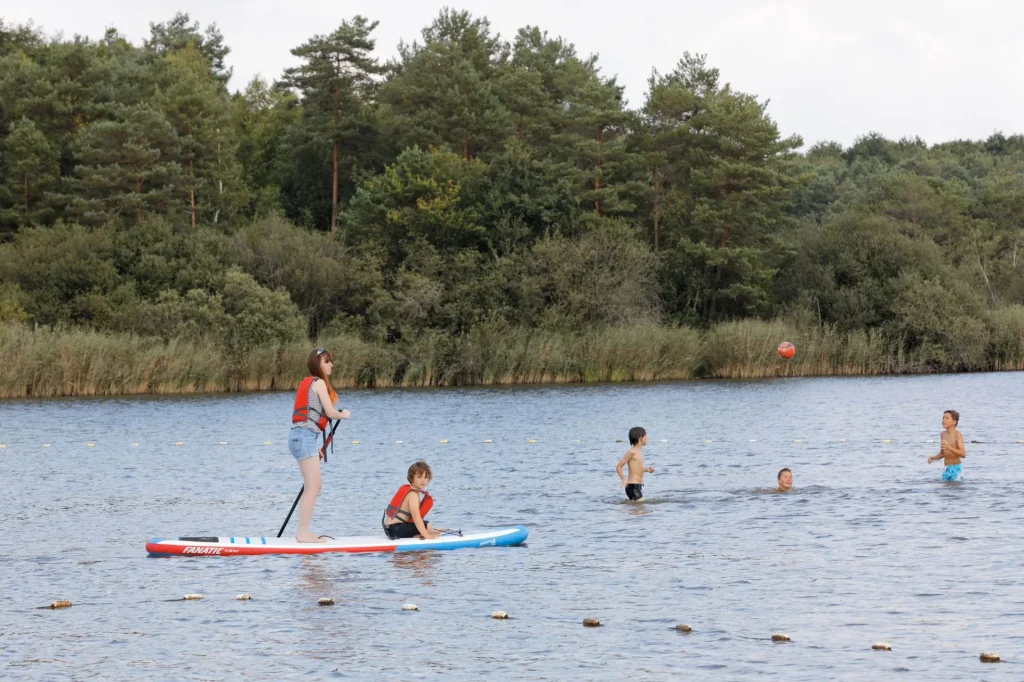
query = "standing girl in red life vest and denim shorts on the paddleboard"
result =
(288, 348, 349, 543)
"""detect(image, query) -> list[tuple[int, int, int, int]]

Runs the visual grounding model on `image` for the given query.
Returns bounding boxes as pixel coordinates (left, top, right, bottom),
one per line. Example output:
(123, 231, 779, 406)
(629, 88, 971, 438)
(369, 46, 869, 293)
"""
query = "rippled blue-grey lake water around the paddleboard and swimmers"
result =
(0, 374, 1024, 681)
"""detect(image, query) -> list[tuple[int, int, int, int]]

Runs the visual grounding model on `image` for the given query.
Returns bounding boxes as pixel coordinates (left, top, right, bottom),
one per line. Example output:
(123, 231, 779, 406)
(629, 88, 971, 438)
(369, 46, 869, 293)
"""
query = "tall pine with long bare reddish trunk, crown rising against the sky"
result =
(285, 15, 382, 233)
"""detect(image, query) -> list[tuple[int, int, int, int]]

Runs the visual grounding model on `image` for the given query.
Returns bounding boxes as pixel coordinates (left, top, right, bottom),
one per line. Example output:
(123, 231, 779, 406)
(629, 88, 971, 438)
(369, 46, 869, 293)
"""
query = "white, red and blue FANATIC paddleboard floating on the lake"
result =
(145, 525, 528, 556)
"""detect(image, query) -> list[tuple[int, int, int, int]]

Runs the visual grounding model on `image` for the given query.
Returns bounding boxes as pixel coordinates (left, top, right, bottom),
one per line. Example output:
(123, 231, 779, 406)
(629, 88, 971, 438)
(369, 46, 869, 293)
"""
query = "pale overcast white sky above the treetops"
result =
(0, 0, 1024, 145)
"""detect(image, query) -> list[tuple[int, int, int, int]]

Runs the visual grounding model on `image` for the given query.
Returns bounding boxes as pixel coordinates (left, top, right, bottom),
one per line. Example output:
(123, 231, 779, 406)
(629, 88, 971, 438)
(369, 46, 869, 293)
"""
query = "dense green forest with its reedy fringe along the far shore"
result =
(0, 9, 1024, 395)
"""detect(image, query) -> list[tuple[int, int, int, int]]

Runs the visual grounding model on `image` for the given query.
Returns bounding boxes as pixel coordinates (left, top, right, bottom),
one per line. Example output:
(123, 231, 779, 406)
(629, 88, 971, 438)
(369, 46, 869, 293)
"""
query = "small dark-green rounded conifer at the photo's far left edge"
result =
(0, 119, 60, 227)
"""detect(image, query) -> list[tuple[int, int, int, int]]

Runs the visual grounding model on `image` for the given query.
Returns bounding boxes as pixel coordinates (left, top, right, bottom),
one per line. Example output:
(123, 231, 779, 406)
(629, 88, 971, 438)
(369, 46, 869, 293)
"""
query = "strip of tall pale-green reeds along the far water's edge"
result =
(0, 313, 1024, 397)
